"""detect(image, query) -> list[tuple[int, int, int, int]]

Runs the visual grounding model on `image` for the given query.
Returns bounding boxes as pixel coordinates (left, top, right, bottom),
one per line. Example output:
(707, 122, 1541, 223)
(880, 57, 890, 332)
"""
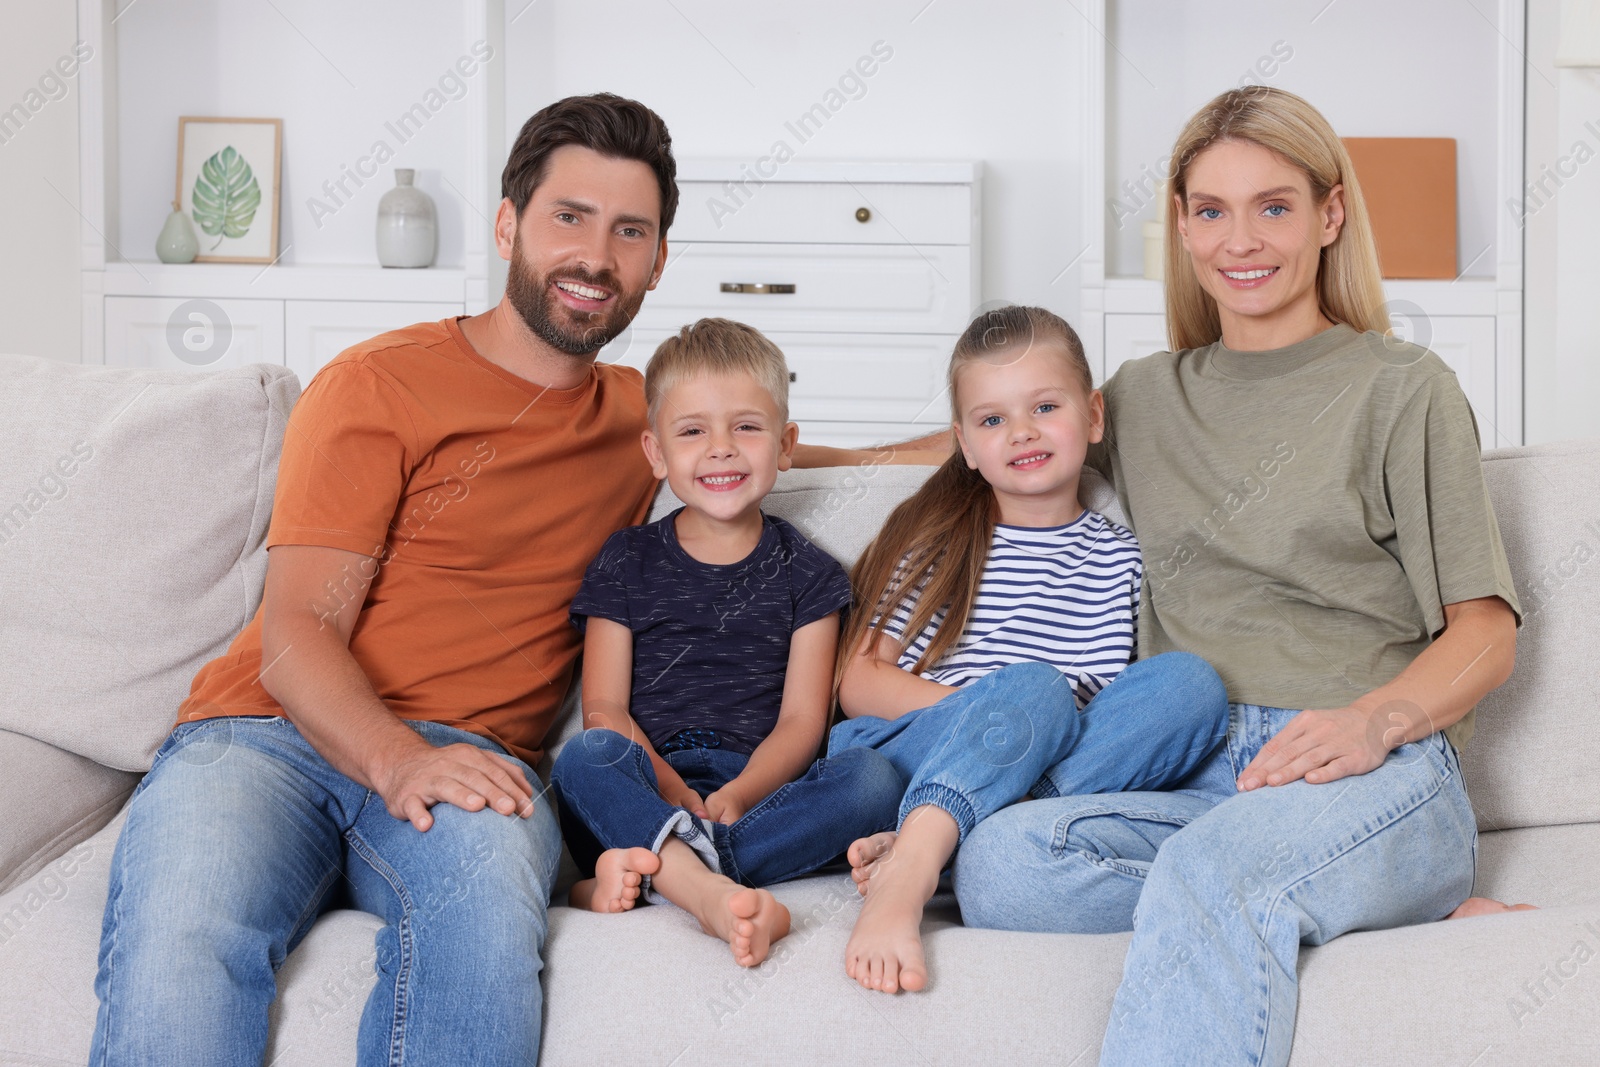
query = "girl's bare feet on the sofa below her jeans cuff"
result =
(845, 806, 960, 993)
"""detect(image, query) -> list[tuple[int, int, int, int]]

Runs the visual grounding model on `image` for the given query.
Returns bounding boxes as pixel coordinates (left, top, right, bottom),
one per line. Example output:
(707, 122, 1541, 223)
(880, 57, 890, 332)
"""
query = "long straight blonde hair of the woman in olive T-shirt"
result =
(1165, 85, 1389, 352)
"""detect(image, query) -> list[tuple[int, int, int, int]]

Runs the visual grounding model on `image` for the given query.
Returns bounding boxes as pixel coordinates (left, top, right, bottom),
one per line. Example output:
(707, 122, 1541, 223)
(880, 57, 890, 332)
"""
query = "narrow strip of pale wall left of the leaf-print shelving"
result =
(0, 0, 82, 362)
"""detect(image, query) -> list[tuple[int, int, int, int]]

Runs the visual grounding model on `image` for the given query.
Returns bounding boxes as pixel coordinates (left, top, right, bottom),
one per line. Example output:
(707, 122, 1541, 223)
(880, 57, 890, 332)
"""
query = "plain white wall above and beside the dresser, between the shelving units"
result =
(506, 0, 1091, 320)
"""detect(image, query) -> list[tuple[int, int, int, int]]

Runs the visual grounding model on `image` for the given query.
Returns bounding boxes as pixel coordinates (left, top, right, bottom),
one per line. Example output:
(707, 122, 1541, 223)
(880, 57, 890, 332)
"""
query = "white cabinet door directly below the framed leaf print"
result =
(106, 296, 283, 370)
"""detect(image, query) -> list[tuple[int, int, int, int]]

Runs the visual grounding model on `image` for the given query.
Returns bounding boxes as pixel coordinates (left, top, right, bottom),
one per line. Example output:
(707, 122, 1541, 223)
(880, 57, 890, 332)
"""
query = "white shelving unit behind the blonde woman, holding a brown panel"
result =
(1080, 0, 1525, 448)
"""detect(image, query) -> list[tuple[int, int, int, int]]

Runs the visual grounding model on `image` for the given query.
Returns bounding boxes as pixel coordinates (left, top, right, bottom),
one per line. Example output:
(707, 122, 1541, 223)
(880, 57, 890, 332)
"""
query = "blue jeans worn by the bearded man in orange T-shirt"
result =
(90, 717, 560, 1067)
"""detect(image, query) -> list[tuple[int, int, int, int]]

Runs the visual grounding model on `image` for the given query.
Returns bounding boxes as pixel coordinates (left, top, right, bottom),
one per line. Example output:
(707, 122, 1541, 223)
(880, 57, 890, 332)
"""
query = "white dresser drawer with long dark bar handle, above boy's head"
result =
(637, 243, 974, 334)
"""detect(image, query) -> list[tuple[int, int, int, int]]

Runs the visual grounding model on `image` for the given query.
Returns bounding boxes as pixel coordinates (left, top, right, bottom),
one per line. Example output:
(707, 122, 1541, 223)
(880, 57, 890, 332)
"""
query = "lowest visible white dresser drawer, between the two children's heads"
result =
(600, 328, 955, 425)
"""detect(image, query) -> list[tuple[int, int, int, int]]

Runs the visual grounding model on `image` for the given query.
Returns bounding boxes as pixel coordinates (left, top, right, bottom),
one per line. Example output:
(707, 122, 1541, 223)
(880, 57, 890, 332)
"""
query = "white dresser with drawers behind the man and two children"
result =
(600, 160, 982, 445)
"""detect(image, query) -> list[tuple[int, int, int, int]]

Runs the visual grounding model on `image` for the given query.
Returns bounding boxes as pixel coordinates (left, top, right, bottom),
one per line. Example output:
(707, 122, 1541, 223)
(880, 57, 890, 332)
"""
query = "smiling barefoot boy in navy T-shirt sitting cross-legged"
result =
(552, 318, 904, 966)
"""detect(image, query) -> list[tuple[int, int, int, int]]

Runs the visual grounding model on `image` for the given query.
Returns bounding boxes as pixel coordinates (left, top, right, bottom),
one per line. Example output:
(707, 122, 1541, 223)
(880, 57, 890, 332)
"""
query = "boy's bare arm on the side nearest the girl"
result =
(706, 611, 838, 822)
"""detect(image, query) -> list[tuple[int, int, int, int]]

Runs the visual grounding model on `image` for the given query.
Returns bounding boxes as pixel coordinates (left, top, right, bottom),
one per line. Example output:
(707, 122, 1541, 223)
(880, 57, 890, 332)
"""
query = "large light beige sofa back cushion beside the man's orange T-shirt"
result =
(0, 355, 299, 771)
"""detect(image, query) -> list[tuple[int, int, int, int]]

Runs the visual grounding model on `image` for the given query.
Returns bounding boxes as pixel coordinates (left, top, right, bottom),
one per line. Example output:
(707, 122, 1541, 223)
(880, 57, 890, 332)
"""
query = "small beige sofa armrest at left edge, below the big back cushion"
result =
(0, 729, 142, 893)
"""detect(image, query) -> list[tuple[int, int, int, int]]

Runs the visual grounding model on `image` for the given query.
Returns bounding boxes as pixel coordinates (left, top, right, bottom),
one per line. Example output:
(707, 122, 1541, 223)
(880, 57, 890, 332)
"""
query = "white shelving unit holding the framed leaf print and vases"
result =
(78, 0, 504, 382)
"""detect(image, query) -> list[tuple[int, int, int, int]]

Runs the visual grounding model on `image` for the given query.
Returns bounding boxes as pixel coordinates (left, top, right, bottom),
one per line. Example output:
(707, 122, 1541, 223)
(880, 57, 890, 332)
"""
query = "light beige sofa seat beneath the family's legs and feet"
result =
(0, 817, 1600, 1067)
